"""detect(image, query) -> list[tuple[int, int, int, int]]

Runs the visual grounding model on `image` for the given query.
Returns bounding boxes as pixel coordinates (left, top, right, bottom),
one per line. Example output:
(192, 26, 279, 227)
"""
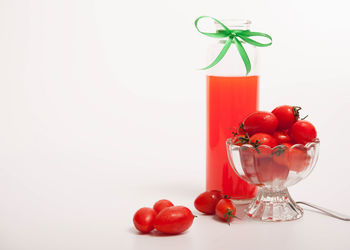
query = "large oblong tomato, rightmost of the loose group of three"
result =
(154, 206, 193, 234)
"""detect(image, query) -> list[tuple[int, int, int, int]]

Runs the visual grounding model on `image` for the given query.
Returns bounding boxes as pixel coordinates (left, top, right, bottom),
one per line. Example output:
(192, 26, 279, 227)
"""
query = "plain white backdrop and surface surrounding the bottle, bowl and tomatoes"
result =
(0, 0, 350, 250)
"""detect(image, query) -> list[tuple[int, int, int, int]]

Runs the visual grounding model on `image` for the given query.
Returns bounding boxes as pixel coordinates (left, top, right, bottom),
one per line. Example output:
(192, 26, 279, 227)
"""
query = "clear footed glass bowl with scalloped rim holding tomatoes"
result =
(226, 138, 320, 221)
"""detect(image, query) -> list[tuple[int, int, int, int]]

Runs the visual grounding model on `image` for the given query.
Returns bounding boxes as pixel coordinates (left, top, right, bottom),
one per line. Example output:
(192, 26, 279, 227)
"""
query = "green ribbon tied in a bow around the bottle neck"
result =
(194, 16, 272, 75)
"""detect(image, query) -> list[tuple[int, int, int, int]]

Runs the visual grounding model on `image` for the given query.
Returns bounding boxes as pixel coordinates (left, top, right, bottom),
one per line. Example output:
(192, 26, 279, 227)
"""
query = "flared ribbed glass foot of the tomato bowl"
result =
(245, 187, 304, 222)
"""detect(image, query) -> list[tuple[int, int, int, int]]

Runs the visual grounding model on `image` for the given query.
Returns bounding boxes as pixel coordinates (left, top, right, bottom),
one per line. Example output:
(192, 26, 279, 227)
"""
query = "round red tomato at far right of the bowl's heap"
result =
(290, 121, 317, 144)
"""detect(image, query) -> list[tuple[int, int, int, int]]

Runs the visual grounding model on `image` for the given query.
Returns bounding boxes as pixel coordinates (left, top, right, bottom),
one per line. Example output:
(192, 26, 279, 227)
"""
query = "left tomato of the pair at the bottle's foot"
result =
(194, 190, 223, 214)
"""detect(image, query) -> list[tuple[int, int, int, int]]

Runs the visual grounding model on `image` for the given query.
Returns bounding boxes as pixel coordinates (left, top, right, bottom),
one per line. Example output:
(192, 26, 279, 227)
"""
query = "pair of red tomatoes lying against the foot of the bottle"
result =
(194, 190, 236, 224)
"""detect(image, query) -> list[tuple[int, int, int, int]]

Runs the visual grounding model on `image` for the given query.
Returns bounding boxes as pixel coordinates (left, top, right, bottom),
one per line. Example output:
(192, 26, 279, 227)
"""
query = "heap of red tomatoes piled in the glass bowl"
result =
(233, 105, 317, 183)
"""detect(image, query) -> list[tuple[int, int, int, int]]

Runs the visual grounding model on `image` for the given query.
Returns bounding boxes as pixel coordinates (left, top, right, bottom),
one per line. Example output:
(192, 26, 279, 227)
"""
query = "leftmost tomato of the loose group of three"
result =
(133, 207, 156, 233)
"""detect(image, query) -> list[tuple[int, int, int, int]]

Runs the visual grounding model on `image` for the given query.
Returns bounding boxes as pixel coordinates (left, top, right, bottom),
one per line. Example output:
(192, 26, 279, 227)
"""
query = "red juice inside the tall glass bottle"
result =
(206, 75, 258, 200)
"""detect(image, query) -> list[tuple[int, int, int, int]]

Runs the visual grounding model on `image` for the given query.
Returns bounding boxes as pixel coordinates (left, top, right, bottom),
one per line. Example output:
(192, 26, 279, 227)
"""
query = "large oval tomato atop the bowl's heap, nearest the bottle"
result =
(243, 111, 278, 136)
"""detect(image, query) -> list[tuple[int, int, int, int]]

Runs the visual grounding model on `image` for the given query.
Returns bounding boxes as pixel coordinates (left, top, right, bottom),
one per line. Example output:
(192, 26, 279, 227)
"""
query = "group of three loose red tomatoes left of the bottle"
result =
(133, 200, 194, 234)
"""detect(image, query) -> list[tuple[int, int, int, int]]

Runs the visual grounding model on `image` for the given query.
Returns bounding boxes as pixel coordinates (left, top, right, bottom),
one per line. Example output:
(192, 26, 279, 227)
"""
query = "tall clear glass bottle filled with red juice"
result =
(206, 19, 259, 203)
